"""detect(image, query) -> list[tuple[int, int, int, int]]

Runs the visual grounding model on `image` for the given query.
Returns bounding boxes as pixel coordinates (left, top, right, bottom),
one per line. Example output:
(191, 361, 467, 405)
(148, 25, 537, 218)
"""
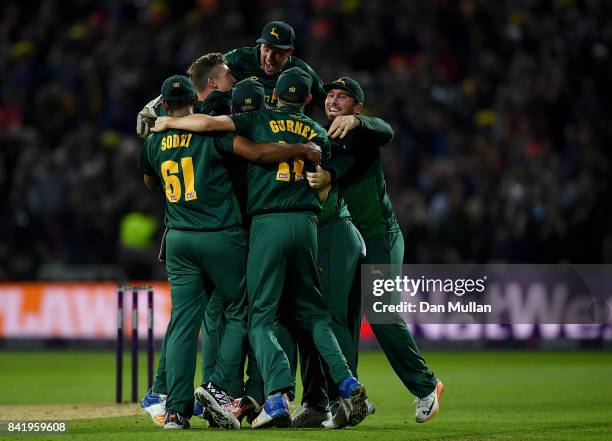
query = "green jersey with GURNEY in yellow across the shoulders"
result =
(231, 107, 330, 216)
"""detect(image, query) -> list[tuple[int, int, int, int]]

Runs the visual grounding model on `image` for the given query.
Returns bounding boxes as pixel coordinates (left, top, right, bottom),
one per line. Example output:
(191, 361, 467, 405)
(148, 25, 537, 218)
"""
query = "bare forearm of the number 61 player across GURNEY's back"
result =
(233, 136, 321, 164)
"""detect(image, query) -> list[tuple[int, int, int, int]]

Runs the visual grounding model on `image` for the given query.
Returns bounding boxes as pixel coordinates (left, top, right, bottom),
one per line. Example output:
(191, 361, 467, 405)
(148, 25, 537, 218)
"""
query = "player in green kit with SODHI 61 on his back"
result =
(139, 75, 320, 429)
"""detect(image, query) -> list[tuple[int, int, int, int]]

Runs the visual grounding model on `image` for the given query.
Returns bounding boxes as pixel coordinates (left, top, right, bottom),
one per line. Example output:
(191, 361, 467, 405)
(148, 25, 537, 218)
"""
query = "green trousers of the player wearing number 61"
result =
(155, 226, 247, 417)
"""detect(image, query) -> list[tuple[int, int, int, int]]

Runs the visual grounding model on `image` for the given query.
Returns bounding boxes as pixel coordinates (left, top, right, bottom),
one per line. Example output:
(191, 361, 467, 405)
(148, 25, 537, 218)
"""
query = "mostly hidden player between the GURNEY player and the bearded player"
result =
(290, 122, 366, 428)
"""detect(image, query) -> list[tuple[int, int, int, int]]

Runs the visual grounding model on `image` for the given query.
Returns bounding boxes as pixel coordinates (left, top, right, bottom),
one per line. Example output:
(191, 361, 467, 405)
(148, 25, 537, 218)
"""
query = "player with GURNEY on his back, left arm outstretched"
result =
(154, 68, 367, 427)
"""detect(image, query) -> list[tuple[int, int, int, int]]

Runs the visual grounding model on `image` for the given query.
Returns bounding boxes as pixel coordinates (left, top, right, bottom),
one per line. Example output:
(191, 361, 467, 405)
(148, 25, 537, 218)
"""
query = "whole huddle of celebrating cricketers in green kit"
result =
(137, 21, 443, 429)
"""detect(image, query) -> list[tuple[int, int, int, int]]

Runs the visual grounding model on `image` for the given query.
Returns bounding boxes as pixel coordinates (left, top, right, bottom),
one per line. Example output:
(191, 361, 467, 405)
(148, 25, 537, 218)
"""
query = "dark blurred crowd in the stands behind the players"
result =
(0, 0, 612, 280)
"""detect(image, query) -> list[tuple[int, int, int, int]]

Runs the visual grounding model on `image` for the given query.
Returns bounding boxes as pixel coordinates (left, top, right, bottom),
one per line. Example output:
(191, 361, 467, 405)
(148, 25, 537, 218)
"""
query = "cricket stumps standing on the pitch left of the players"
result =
(115, 285, 155, 403)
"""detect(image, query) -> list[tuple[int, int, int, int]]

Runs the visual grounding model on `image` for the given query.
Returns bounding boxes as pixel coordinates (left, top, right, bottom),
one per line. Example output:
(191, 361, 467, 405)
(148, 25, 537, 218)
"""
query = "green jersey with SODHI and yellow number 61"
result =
(139, 130, 239, 231)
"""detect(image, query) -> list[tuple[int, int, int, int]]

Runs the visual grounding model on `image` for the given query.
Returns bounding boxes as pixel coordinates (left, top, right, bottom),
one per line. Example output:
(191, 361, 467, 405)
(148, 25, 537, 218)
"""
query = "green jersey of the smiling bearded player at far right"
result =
(338, 115, 399, 239)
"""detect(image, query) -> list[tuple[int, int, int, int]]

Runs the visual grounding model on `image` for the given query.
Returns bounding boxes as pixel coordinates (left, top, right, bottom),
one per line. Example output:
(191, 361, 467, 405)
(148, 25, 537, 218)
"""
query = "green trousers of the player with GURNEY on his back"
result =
(247, 212, 351, 396)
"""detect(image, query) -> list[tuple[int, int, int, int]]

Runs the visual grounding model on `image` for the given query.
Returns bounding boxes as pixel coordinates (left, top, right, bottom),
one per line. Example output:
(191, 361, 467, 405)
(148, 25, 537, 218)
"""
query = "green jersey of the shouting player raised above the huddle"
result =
(225, 46, 326, 111)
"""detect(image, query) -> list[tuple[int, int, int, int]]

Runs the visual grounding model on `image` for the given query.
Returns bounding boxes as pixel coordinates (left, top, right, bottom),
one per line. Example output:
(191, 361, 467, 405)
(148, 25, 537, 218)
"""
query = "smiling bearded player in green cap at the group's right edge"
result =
(308, 77, 443, 423)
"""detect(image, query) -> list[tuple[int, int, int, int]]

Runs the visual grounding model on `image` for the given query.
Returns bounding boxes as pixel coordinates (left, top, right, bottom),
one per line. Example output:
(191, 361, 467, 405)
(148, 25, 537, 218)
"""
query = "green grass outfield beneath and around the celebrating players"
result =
(0, 351, 612, 441)
